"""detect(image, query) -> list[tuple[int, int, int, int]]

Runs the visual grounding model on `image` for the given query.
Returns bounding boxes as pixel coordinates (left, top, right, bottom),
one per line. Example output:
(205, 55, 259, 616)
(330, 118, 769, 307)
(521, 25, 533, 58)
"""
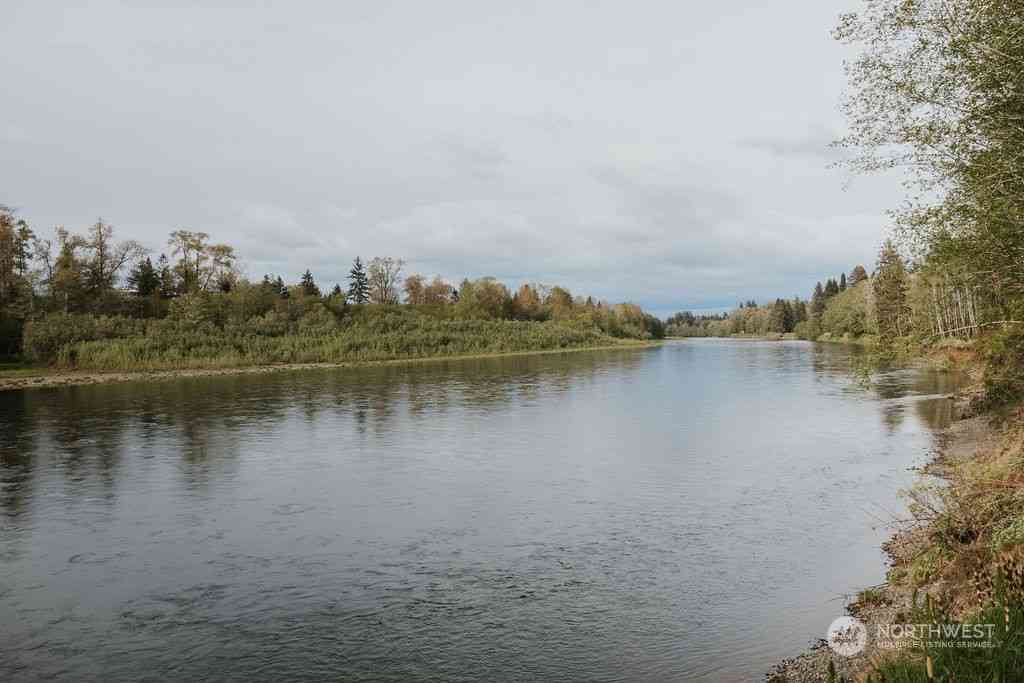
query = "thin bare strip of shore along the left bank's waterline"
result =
(0, 340, 662, 391)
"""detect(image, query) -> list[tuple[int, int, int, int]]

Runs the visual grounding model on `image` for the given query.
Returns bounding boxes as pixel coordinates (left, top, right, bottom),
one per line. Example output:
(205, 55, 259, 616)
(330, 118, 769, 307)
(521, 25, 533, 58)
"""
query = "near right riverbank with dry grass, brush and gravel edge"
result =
(766, 349, 1024, 683)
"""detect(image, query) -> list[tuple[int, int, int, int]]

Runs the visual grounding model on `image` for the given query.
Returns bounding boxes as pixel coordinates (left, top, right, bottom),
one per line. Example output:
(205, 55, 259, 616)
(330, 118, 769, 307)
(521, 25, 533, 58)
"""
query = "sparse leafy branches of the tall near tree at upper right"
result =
(836, 0, 1024, 304)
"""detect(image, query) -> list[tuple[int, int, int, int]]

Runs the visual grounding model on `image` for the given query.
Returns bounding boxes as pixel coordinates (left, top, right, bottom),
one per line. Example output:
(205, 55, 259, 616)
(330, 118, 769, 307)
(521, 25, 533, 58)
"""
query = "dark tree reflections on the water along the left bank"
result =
(0, 351, 644, 515)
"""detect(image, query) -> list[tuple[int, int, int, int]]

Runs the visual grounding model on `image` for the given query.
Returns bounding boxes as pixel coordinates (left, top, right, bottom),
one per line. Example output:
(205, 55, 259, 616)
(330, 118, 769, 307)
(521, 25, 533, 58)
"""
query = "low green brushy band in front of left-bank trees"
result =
(26, 309, 629, 371)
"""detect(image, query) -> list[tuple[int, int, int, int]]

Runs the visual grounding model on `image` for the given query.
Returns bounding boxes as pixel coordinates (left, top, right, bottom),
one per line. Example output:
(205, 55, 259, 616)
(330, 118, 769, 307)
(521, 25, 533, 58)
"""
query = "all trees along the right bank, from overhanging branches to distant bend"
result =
(669, 0, 1024, 362)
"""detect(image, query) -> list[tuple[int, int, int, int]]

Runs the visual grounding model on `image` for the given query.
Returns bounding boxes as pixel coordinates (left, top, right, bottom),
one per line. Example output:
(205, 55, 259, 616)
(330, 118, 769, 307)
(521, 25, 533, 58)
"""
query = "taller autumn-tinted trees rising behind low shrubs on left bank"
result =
(0, 208, 664, 359)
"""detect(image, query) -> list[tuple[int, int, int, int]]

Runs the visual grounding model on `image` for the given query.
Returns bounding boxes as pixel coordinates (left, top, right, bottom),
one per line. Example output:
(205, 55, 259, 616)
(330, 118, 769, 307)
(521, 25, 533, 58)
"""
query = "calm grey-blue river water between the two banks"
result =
(0, 340, 952, 681)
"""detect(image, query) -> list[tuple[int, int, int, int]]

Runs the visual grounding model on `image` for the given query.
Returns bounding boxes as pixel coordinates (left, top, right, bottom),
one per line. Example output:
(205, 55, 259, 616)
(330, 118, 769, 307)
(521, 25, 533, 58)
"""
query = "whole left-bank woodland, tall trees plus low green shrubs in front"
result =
(0, 215, 665, 369)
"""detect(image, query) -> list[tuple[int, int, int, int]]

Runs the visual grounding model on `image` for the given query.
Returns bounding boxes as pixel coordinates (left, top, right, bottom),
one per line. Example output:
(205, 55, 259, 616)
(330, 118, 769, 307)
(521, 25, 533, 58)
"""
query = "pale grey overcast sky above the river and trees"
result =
(0, 0, 898, 314)
